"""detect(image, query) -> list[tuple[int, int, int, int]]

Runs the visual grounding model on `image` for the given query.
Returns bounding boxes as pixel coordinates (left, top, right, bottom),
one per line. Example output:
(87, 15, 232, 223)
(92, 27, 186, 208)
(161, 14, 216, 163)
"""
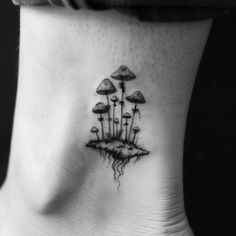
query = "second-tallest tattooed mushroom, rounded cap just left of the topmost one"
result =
(96, 79, 116, 139)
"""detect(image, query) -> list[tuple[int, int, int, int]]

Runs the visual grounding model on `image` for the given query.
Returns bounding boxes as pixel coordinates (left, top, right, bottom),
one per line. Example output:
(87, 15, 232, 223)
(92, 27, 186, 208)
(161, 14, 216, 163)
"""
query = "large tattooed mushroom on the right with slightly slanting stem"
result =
(126, 91, 146, 143)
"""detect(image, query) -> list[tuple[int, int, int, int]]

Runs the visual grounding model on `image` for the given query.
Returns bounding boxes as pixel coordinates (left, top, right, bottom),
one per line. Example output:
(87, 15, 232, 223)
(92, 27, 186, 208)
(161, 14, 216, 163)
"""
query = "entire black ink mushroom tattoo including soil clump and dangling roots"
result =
(86, 66, 149, 185)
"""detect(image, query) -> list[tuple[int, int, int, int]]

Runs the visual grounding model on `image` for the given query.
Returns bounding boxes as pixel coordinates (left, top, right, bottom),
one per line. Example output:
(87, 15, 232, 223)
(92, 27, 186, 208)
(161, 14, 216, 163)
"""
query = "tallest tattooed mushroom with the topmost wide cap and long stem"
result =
(111, 66, 136, 136)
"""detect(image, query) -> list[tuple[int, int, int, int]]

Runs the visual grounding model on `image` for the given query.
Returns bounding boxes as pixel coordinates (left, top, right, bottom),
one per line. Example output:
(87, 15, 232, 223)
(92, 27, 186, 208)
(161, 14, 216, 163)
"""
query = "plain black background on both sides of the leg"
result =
(0, 0, 236, 236)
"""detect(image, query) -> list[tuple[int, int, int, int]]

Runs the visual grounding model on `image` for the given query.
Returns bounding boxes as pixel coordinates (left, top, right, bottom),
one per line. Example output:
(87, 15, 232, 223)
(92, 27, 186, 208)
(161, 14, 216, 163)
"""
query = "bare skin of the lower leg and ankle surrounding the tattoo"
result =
(0, 7, 211, 236)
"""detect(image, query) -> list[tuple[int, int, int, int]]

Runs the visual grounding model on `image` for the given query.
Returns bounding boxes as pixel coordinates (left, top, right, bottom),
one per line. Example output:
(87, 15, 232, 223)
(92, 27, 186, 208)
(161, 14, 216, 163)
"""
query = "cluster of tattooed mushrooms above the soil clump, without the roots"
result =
(91, 66, 145, 144)
